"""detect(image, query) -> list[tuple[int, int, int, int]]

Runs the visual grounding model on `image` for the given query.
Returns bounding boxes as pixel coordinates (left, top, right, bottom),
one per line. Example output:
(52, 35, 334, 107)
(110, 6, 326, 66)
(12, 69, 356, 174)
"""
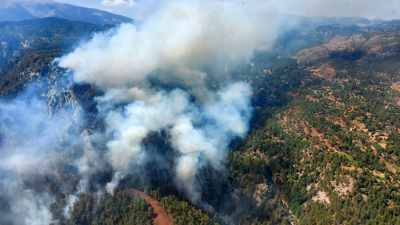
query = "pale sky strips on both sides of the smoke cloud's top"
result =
(57, 0, 400, 20)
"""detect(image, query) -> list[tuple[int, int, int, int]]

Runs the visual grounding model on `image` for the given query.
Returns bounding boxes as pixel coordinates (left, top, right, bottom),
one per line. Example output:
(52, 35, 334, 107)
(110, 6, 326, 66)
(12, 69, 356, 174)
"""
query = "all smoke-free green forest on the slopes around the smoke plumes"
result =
(0, 11, 400, 225)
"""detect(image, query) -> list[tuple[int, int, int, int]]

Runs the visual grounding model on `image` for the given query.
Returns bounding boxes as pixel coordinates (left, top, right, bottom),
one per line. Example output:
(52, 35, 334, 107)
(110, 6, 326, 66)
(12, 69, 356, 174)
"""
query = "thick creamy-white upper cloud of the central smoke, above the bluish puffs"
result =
(60, 2, 271, 88)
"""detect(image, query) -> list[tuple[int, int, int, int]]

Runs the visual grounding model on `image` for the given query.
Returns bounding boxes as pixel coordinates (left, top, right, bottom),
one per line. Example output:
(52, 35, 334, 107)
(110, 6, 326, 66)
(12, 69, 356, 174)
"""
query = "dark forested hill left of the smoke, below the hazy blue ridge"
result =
(0, 17, 114, 96)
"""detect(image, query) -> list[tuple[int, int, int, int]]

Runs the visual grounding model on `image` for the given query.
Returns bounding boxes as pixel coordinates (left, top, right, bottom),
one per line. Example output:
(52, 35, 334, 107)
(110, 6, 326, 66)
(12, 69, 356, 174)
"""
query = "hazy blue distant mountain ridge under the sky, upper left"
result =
(0, 0, 132, 24)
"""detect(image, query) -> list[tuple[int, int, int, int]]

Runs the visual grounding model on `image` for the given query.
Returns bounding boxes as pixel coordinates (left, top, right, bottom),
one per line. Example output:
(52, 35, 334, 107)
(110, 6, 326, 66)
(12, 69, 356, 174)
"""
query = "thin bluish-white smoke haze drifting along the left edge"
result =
(0, 79, 107, 225)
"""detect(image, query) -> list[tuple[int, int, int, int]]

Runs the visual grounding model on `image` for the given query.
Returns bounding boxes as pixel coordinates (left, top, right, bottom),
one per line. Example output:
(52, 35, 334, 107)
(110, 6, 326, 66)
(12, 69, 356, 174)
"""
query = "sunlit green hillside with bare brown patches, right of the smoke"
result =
(231, 22, 400, 224)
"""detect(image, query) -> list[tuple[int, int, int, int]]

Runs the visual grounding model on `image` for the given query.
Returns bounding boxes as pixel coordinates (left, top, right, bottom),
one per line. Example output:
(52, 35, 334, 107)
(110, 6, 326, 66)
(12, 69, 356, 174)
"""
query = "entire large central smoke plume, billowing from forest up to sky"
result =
(57, 1, 268, 201)
